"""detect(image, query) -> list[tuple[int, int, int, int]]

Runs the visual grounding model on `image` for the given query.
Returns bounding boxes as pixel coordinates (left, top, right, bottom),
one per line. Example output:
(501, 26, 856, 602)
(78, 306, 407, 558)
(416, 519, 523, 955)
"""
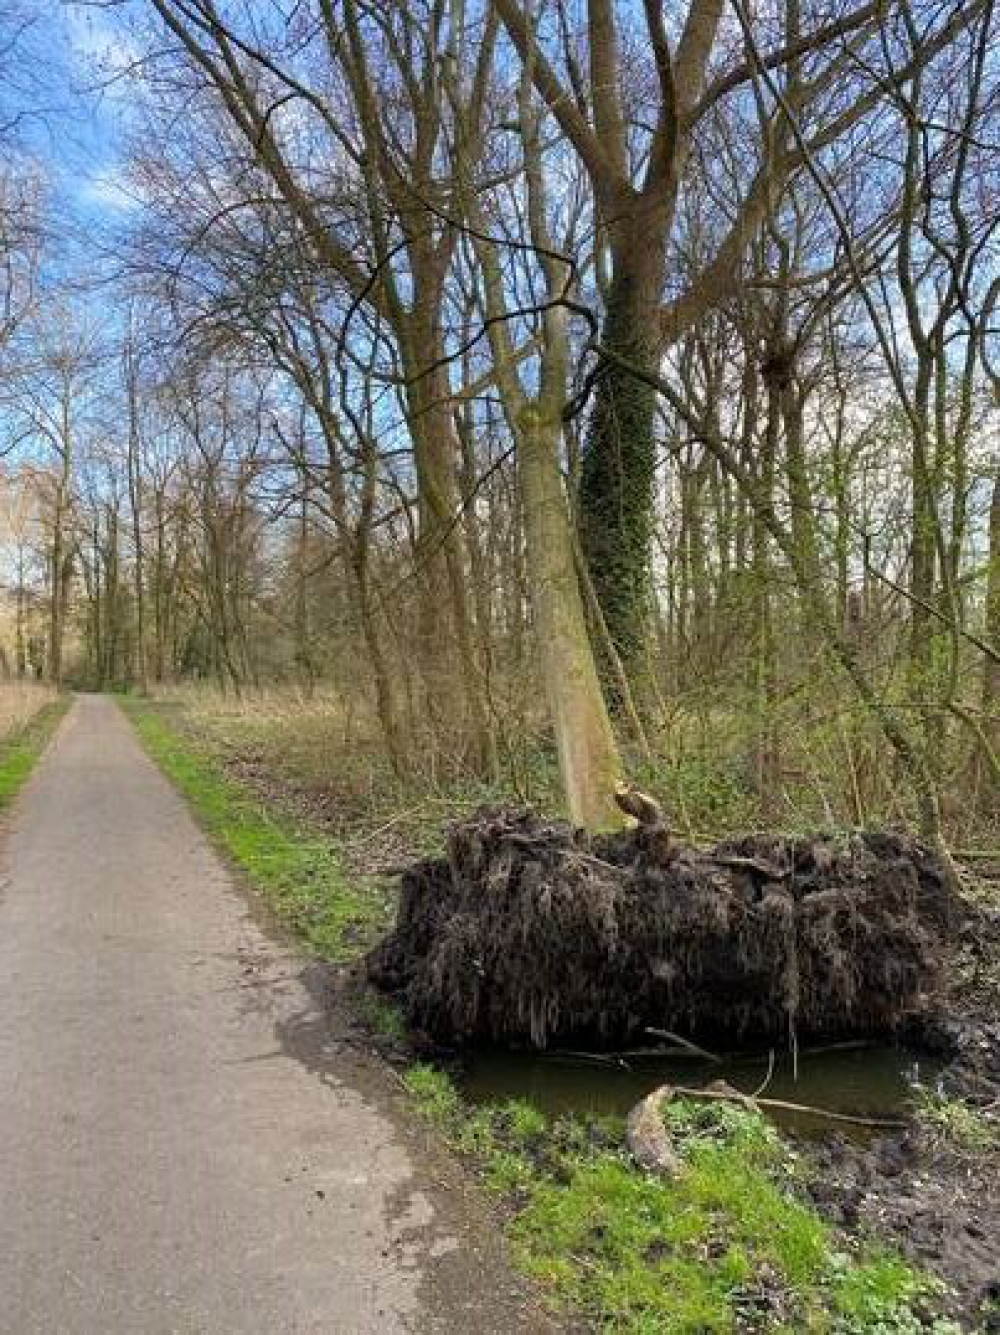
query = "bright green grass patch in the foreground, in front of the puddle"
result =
(405, 1064, 955, 1335)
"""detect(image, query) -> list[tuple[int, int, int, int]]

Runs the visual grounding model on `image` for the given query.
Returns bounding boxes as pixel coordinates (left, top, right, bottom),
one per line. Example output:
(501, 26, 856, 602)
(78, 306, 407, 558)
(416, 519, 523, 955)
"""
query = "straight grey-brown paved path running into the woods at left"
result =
(0, 697, 542, 1335)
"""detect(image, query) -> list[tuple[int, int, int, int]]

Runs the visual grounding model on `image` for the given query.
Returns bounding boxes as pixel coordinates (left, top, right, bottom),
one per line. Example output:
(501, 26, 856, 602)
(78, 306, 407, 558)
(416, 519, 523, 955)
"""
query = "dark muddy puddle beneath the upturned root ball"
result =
(461, 1044, 940, 1136)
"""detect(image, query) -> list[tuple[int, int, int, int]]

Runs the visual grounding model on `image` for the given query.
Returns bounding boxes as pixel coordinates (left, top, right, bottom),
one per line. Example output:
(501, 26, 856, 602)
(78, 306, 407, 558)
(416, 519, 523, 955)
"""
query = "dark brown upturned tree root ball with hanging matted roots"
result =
(368, 810, 961, 1048)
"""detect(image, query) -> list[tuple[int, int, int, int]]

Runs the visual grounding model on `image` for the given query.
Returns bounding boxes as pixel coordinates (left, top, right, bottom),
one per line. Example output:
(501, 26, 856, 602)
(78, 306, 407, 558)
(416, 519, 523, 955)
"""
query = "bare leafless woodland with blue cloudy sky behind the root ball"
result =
(0, 0, 1000, 853)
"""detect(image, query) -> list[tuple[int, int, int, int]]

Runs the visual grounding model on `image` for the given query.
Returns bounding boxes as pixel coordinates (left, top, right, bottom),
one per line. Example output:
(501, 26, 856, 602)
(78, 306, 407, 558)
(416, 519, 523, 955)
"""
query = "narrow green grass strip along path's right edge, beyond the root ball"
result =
(121, 700, 390, 961)
